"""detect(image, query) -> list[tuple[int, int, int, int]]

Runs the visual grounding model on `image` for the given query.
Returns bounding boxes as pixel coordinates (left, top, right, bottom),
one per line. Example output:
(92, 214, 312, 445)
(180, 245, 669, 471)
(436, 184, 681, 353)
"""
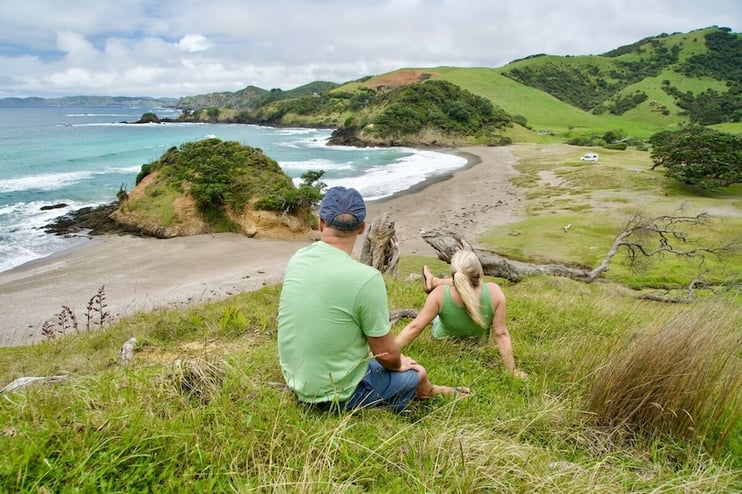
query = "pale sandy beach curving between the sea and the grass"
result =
(0, 146, 522, 346)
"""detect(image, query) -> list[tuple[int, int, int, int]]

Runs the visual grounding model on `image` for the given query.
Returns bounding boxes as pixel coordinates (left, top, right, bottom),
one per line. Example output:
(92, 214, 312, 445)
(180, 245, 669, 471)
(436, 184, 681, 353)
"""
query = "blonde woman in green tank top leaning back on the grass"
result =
(396, 250, 528, 378)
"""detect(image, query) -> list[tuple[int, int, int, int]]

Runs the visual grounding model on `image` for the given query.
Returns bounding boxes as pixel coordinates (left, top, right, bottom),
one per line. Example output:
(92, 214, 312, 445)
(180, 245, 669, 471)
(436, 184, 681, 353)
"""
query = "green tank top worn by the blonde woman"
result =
(433, 283, 495, 338)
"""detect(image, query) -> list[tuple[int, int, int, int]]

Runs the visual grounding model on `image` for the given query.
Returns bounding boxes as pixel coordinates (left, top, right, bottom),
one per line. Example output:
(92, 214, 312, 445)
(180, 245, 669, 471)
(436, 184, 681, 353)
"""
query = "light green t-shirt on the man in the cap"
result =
(278, 241, 390, 403)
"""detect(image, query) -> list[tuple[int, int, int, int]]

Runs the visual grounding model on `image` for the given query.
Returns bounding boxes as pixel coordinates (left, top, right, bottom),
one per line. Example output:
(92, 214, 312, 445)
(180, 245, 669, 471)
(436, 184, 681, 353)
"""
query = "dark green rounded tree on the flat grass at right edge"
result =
(650, 126, 742, 190)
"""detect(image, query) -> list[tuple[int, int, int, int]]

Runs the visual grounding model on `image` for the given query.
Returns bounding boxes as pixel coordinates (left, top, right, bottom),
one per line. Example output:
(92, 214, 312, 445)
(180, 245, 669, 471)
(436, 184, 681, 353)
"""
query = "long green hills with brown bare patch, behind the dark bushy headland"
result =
(178, 26, 742, 142)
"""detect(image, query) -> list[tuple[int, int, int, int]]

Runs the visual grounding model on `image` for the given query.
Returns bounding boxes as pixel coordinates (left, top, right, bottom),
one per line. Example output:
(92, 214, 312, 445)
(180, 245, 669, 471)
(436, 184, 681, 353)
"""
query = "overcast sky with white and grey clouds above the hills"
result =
(0, 0, 742, 98)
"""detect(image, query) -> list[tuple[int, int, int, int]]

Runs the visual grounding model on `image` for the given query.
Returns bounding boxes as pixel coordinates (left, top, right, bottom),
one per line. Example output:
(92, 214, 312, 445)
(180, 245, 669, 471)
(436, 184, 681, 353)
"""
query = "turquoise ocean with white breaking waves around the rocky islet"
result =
(0, 106, 466, 271)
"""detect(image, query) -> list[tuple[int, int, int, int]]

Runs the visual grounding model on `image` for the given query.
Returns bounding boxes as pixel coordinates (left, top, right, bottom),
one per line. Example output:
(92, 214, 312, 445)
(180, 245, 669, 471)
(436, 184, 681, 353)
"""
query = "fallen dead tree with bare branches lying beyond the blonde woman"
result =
(422, 213, 739, 294)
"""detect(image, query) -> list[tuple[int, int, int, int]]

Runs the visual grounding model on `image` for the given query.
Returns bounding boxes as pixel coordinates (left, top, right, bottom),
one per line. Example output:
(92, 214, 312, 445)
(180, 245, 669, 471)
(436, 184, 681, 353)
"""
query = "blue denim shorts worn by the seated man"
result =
(315, 359, 420, 413)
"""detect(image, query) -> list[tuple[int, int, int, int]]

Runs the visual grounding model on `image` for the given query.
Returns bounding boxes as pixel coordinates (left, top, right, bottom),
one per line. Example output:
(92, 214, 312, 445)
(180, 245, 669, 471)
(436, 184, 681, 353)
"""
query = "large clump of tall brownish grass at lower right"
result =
(587, 302, 742, 454)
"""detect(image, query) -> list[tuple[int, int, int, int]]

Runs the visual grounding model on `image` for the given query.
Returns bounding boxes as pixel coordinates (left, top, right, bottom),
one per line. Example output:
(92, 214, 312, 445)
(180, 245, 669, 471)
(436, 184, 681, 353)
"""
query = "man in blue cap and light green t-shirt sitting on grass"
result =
(278, 187, 469, 412)
